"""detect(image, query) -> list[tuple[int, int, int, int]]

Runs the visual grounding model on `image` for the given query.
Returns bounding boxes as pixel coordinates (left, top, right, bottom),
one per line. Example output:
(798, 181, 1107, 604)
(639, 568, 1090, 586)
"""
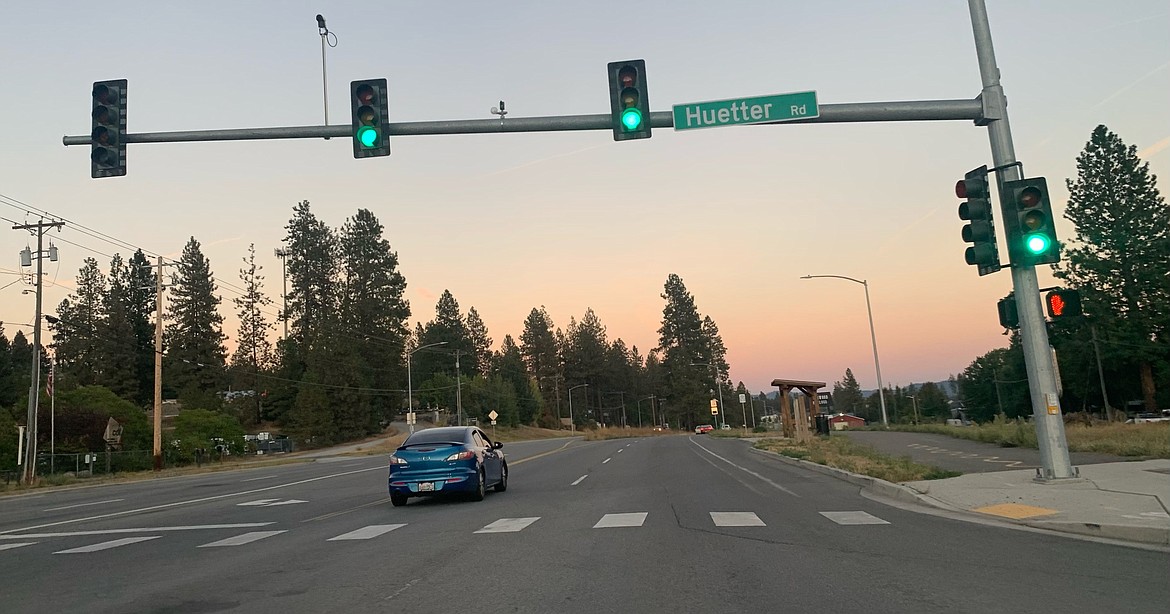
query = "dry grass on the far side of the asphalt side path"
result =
(890, 416, 1170, 458)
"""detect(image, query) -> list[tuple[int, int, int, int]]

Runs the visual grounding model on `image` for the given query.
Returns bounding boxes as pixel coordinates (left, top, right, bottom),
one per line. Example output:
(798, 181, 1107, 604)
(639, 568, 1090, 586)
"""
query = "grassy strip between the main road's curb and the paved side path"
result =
(755, 436, 963, 482)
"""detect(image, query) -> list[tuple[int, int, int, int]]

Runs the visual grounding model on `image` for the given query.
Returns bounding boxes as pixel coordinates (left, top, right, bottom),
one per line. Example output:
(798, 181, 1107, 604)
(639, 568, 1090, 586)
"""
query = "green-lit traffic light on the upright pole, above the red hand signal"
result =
(1002, 177, 1060, 267)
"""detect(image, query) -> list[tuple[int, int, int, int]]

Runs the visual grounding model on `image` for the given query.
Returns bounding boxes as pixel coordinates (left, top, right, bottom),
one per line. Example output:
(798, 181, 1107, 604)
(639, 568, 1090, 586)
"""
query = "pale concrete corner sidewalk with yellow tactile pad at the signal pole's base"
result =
(893, 458, 1170, 546)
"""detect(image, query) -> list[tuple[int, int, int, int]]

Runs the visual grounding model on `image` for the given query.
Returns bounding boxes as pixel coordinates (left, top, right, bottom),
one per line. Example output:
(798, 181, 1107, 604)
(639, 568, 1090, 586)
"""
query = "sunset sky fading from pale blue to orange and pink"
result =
(0, 0, 1170, 391)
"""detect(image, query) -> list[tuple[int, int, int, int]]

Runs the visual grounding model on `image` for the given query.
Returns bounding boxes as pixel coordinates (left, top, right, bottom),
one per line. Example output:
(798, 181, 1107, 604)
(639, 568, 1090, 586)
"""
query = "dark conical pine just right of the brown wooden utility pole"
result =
(163, 236, 226, 409)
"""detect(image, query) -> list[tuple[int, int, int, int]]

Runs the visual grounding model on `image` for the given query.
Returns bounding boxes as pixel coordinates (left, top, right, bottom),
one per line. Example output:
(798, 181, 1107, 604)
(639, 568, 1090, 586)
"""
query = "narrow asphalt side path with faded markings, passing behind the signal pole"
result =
(847, 430, 1133, 474)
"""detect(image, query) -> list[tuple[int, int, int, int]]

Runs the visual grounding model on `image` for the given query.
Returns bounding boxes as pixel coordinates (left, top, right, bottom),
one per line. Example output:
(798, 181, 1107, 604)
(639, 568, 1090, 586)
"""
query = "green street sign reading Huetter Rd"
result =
(674, 91, 820, 130)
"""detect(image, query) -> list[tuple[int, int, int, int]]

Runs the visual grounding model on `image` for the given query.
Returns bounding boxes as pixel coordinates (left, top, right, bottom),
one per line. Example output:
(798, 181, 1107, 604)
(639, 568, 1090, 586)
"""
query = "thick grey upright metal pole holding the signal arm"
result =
(968, 0, 1076, 482)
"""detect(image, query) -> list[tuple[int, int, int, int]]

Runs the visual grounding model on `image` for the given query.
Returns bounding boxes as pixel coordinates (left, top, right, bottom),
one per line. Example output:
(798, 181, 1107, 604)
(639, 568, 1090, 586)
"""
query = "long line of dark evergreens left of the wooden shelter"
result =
(0, 201, 743, 449)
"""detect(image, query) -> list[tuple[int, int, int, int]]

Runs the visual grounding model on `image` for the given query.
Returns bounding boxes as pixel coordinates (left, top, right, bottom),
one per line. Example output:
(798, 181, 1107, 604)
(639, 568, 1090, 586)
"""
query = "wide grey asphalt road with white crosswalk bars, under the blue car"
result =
(0, 435, 1170, 614)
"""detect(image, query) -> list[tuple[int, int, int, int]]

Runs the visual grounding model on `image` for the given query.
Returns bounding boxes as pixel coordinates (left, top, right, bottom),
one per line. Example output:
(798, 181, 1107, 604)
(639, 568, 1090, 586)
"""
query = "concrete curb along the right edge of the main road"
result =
(751, 447, 1170, 546)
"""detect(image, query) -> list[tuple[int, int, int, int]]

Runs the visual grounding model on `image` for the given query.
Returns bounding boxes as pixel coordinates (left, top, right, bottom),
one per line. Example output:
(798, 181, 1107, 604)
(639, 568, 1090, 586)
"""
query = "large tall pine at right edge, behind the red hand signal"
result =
(1055, 125, 1170, 412)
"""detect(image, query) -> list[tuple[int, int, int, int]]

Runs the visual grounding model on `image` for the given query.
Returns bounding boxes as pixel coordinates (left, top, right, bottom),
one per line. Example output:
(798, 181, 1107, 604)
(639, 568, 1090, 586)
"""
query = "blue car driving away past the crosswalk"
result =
(390, 427, 508, 508)
